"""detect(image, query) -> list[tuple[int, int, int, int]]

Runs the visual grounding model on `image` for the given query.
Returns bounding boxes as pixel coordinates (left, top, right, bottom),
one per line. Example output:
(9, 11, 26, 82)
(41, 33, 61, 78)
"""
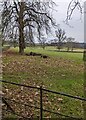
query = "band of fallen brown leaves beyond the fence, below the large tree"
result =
(3, 50, 84, 77)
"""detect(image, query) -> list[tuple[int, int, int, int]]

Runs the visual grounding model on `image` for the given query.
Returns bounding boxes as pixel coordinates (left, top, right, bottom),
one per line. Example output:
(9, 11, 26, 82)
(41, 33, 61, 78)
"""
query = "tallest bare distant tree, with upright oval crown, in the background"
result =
(55, 28, 66, 51)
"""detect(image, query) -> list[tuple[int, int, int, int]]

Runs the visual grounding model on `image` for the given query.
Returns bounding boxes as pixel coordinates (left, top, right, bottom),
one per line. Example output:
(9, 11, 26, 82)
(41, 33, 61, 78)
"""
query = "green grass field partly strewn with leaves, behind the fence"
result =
(3, 47, 84, 117)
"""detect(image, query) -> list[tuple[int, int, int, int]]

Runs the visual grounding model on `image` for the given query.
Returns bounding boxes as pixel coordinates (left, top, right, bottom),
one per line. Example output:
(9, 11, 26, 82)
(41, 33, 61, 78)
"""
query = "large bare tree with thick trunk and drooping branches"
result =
(2, 0, 55, 54)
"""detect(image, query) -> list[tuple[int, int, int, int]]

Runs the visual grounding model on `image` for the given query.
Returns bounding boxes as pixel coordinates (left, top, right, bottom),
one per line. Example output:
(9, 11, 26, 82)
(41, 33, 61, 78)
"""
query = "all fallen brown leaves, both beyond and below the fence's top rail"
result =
(3, 52, 83, 117)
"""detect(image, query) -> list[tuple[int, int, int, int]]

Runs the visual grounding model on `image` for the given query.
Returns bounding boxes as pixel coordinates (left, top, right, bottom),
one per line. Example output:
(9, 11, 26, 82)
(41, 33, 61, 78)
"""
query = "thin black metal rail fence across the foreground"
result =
(0, 80, 86, 120)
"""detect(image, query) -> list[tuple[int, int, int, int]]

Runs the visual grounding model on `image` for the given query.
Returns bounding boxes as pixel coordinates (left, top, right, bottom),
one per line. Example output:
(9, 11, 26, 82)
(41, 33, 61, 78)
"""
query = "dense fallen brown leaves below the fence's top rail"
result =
(3, 85, 63, 118)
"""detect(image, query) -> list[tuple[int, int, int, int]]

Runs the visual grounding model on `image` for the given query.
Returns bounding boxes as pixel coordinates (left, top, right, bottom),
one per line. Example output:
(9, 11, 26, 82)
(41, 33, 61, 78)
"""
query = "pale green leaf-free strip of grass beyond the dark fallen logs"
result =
(11, 47, 83, 62)
